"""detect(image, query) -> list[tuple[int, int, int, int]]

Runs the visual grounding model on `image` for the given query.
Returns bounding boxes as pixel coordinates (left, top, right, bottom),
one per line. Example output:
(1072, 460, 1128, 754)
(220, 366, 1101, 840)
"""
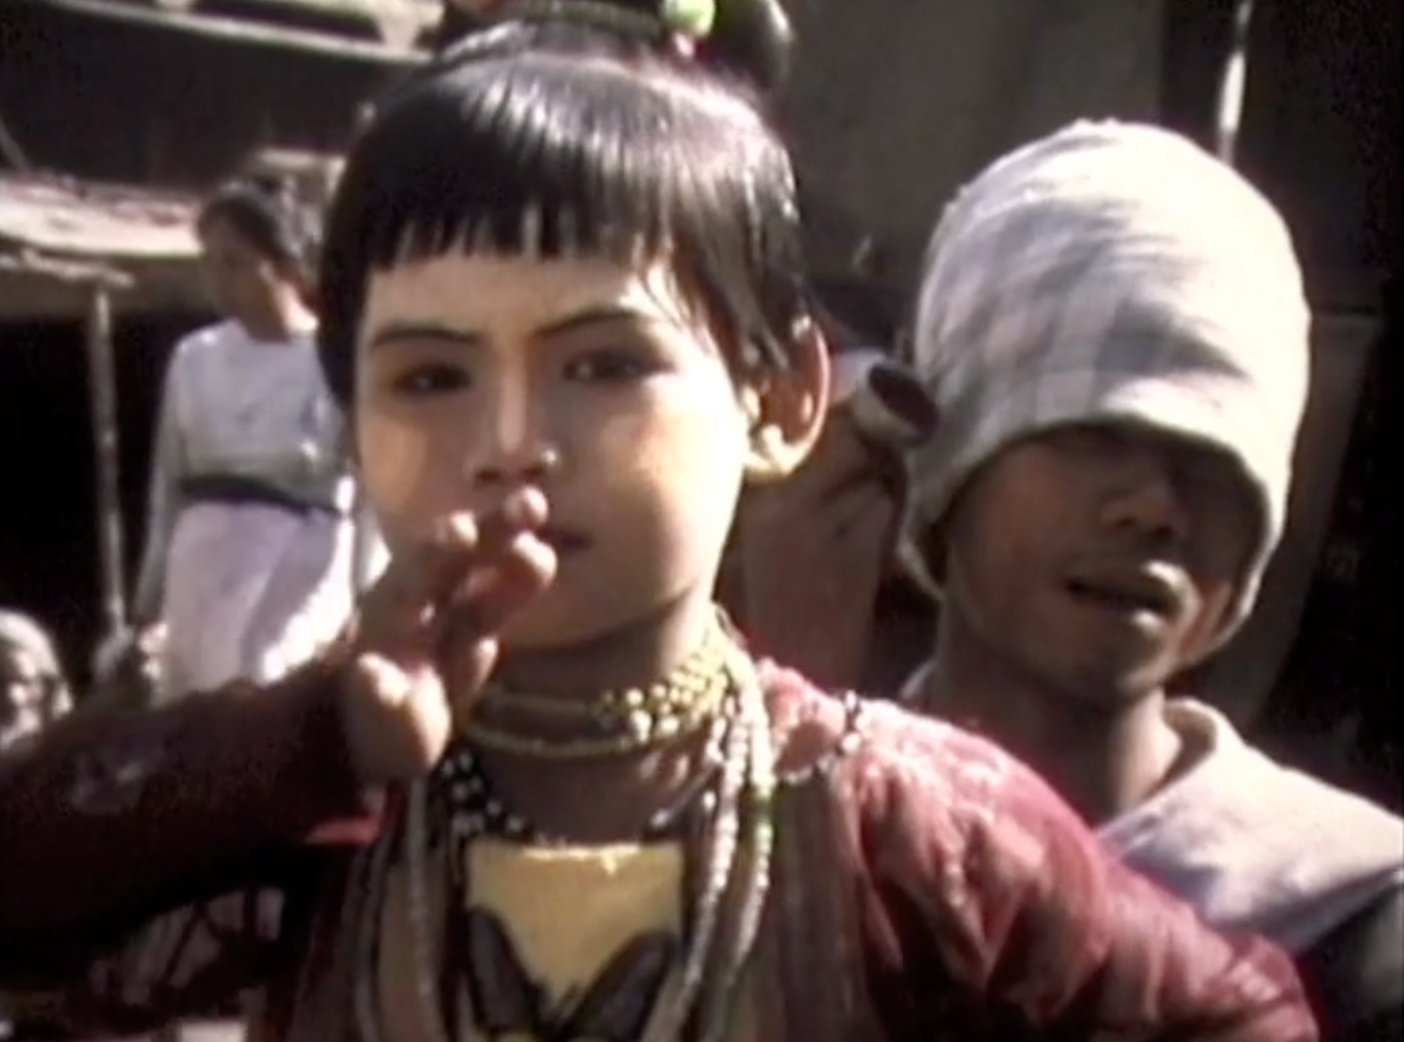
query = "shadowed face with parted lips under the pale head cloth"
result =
(943, 424, 1259, 708)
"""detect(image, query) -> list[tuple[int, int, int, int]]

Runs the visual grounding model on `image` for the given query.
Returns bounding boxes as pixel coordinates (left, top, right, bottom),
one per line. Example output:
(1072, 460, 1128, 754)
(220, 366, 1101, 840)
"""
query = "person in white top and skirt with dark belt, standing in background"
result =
(133, 183, 357, 699)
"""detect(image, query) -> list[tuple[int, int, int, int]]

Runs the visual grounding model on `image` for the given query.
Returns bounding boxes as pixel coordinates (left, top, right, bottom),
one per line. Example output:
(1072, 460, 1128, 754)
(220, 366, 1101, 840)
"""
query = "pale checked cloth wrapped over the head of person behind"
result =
(910, 122, 1310, 640)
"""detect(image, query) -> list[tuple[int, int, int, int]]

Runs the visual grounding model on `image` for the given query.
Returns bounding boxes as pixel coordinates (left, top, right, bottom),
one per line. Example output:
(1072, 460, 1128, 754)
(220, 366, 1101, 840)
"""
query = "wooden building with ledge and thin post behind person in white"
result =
(0, 0, 415, 684)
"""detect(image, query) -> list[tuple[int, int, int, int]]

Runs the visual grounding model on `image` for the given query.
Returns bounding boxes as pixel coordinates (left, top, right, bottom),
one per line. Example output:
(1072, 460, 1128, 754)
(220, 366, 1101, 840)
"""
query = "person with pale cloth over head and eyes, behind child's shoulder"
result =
(907, 122, 1404, 1039)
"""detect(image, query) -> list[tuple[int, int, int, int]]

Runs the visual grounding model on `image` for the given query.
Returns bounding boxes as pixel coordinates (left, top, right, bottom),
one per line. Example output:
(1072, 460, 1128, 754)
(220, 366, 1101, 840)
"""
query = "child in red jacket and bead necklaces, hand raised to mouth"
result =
(0, 0, 1314, 1042)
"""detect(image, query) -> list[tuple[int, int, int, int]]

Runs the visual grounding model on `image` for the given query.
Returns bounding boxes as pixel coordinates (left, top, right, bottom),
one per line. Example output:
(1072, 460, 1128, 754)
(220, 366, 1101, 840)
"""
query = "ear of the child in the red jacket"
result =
(741, 319, 830, 483)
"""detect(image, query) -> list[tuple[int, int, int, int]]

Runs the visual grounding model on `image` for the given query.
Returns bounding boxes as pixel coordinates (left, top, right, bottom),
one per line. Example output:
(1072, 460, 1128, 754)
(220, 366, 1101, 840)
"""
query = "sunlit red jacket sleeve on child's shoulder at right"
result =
(859, 706, 1317, 1042)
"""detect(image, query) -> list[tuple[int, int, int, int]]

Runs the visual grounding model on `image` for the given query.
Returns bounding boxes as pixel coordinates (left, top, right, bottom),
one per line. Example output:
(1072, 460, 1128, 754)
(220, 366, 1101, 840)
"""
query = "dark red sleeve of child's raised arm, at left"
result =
(0, 664, 376, 986)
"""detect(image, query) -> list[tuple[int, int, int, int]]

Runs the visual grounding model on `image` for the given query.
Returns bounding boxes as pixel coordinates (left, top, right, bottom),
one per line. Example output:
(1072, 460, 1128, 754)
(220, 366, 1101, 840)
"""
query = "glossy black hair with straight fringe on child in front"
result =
(317, 0, 809, 402)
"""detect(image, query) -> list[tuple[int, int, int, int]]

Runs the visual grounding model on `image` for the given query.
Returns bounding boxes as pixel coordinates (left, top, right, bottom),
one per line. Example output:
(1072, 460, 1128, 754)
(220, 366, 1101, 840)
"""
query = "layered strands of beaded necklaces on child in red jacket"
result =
(355, 618, 819, 1042)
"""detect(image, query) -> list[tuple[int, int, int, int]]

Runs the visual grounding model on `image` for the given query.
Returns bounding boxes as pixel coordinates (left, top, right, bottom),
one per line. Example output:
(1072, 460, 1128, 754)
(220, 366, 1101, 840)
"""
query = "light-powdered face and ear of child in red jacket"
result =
(355, 253, 827, 650)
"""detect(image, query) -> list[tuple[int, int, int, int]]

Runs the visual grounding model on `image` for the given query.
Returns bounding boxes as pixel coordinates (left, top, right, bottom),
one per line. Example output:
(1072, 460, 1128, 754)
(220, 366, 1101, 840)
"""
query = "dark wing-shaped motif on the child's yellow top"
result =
(465, 909, 681, 1042)
